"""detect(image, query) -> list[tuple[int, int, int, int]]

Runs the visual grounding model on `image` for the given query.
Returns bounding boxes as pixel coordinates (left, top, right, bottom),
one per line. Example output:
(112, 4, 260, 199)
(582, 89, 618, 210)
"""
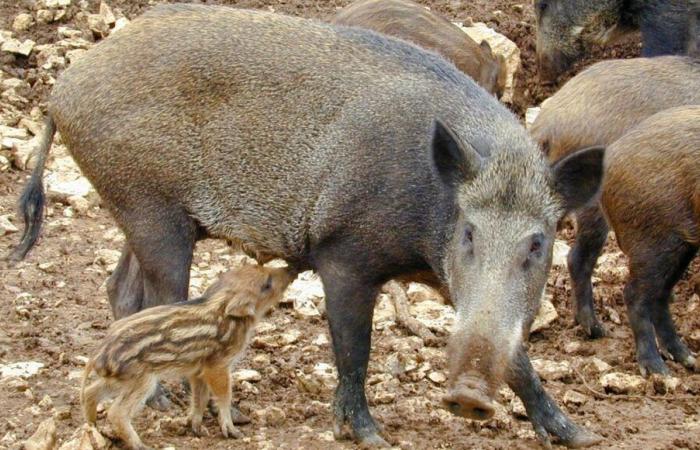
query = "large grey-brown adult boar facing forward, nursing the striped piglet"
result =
(10, 5, 603, 445)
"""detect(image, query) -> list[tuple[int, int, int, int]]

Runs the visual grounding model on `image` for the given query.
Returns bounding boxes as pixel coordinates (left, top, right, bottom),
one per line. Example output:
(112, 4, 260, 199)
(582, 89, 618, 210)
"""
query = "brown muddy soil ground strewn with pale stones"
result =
(0, 0, 700, 449)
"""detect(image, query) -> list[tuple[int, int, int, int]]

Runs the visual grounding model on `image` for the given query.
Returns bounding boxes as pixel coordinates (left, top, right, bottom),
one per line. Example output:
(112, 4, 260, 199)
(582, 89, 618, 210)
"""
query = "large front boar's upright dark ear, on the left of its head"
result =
(432, 120, 482, 186)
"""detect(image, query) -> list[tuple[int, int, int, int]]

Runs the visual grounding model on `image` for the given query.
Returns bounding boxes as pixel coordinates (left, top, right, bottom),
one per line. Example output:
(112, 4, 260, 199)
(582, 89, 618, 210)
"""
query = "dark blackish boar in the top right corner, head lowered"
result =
(535, 0, 694, 82)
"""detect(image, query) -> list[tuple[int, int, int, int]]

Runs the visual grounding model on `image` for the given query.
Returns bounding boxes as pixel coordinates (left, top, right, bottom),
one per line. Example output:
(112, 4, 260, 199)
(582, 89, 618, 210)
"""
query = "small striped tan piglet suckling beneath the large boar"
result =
(80, 265, 293, 449)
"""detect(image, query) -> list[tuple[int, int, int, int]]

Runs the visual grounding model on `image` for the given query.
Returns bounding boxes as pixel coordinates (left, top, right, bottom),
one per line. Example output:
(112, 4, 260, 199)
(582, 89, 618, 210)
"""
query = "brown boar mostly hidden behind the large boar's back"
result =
(331, 0, 507, 98)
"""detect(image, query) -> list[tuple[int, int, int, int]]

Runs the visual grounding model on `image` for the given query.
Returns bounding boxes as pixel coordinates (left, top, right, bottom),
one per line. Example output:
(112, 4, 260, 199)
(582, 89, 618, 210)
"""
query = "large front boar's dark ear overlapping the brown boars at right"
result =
(552, 147, 605, 212)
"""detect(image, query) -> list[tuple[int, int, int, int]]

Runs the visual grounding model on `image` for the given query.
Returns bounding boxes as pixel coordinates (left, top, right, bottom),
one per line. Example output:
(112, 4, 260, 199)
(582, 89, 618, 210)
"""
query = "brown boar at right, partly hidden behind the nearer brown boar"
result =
(530, 56, 700, 338)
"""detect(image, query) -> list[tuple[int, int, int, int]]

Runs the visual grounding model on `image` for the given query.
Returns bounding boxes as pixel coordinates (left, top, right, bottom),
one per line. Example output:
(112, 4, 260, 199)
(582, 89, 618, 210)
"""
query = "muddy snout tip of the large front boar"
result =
(442, 375, 496, 420)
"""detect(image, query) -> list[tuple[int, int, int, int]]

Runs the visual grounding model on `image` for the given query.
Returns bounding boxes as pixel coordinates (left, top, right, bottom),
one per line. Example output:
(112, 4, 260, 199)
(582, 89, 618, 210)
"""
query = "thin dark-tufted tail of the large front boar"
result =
(8, 117, 56, 262)
